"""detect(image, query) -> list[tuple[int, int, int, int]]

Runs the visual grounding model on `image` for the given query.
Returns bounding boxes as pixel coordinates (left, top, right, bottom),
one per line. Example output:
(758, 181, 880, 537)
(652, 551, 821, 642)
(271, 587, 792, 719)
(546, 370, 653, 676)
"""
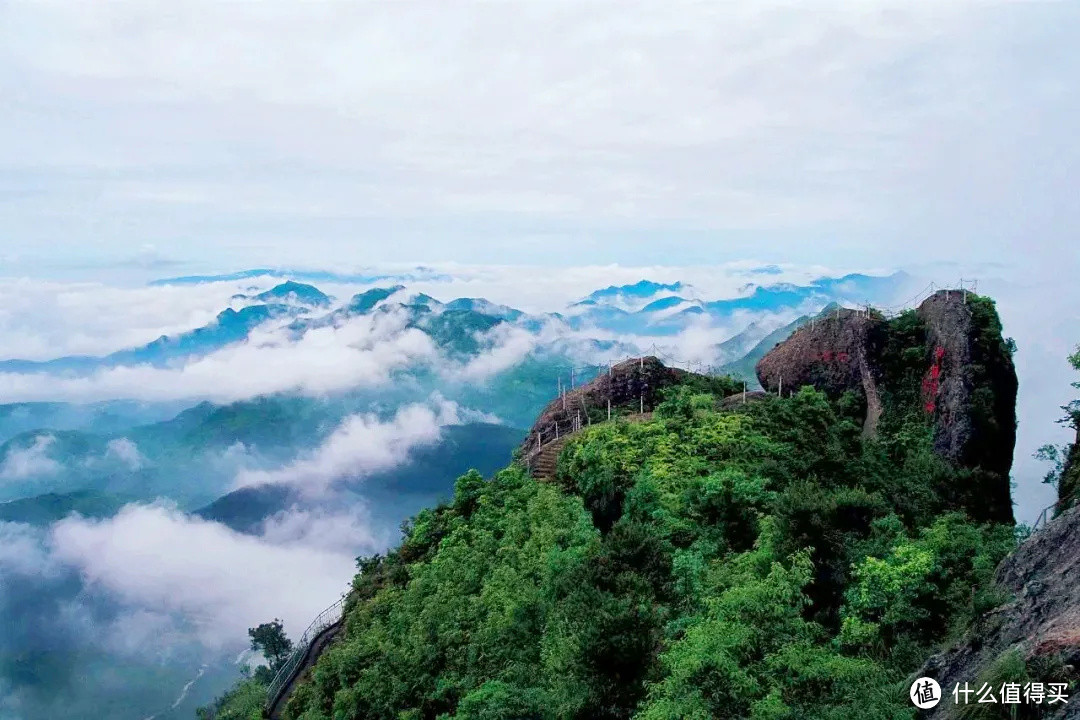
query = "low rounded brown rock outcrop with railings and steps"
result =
(522, 357, 688, 457)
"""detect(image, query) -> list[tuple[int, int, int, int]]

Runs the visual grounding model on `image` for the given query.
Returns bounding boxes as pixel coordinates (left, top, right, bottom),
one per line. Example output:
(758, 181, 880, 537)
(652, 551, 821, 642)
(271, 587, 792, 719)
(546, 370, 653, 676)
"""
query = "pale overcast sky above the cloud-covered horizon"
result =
(0, 1, 1080, 275)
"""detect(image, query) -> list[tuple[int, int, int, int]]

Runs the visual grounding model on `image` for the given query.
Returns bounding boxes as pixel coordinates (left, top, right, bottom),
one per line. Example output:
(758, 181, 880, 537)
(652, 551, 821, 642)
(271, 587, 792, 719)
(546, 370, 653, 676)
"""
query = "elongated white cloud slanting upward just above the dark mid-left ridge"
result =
(235, 397, 461, 494)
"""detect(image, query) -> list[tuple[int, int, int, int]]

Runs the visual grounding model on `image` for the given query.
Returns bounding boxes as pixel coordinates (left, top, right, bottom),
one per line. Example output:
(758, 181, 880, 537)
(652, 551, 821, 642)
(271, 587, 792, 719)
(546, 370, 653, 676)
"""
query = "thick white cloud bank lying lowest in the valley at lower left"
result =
(50, 505, 354, 647)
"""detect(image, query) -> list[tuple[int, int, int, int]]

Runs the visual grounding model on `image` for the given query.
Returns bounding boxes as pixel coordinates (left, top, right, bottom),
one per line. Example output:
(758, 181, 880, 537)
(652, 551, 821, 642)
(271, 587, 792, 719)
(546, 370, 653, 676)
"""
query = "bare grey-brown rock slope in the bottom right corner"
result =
(919, 507, 1080, 720)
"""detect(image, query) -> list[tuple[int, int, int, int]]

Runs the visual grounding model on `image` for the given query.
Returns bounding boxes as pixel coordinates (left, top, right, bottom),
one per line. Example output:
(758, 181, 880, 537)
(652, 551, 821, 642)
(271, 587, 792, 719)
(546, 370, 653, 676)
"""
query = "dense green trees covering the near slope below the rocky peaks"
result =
(240, 377, 1013, 720)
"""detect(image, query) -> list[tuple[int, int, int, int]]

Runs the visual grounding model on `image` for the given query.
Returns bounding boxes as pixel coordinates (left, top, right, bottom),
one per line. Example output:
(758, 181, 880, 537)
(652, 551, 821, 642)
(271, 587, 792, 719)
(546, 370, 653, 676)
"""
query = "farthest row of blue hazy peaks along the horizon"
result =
(0, 270, 913, 373)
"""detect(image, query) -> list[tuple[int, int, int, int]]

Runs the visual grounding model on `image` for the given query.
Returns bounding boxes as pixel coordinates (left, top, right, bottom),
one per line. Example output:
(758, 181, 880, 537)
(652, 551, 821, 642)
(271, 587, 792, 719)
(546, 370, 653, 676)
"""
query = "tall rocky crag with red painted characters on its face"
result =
(757, 290, 1017, 522)
